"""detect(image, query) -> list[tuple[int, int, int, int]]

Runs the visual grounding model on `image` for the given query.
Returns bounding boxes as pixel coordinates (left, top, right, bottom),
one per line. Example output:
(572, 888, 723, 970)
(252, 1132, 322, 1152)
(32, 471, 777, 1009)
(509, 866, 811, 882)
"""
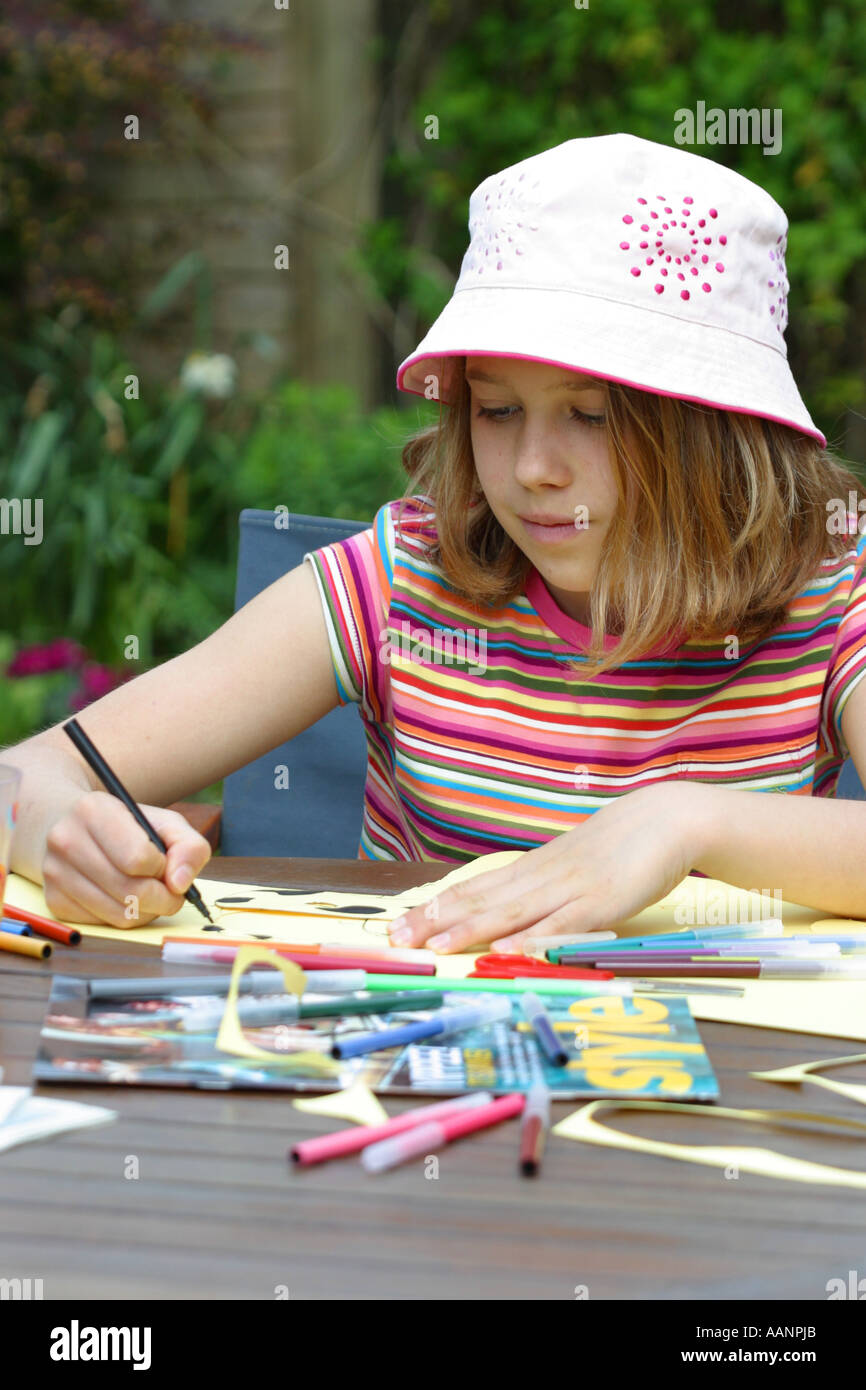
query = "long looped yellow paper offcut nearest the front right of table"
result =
(550, 1101, 866, 1188)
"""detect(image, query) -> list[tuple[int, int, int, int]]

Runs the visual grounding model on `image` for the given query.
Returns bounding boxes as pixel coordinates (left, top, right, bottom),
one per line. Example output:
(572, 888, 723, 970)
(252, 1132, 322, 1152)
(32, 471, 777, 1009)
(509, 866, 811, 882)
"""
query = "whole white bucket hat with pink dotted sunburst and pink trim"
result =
(396, 135, 827, 446)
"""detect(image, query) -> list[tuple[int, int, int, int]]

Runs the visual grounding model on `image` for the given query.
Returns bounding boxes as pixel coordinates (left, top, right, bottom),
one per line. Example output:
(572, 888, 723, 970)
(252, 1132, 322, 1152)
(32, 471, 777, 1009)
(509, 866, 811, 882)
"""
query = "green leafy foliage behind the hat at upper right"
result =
(375, 0, 866, 442)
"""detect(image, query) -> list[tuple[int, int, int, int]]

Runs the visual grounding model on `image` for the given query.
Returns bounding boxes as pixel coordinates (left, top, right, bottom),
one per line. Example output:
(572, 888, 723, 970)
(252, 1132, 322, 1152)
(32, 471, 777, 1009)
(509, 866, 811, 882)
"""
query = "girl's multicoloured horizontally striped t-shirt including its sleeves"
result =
(304, 496, 866, 863)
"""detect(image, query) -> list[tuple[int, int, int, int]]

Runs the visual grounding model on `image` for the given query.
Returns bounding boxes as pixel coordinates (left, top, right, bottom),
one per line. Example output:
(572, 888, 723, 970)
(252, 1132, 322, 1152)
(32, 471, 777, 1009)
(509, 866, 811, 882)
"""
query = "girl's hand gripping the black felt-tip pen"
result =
(42, 791, 211, 929)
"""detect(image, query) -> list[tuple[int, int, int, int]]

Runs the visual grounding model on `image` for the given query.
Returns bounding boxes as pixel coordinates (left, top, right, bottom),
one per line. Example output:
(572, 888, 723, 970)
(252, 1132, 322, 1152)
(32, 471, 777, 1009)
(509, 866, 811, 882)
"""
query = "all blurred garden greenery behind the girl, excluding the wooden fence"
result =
(0, 0, 866, 761)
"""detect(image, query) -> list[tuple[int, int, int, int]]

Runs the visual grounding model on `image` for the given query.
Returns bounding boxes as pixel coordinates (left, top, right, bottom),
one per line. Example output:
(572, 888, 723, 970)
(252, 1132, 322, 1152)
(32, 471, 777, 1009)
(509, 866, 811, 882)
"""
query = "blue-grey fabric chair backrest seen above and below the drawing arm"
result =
(220, 509, 370, 859)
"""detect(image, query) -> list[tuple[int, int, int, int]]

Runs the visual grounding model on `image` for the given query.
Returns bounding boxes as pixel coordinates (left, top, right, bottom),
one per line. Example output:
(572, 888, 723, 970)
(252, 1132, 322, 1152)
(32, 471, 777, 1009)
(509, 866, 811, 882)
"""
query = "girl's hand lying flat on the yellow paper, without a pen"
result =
(391, 783, 701, 954)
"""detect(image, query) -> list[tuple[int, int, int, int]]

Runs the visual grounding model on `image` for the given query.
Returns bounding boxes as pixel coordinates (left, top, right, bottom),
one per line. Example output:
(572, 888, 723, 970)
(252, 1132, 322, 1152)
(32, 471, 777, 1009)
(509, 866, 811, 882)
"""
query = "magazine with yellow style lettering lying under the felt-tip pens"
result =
(33, 976, 719, 1101)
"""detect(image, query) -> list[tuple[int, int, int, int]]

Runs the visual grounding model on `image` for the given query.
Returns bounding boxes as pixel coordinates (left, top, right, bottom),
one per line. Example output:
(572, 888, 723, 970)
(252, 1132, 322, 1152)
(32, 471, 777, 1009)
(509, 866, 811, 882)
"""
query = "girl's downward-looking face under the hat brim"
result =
(466, 356, 617, 626)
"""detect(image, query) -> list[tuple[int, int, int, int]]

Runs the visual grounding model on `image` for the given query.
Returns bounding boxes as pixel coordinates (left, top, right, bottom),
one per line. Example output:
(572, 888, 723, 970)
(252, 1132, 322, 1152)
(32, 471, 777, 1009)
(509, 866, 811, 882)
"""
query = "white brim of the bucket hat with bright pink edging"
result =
(396, 286, 827, 448)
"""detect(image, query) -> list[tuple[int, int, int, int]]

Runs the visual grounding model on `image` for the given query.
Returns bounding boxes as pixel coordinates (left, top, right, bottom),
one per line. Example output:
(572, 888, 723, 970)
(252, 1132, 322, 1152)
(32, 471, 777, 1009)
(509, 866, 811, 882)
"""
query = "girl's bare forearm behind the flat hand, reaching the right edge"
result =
(681, 783, 866, 917)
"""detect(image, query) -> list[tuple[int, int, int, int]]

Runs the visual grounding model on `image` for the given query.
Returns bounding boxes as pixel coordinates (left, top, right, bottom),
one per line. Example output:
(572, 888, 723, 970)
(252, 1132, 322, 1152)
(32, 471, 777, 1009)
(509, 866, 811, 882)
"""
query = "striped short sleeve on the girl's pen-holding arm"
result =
(304, 503, 395, 723)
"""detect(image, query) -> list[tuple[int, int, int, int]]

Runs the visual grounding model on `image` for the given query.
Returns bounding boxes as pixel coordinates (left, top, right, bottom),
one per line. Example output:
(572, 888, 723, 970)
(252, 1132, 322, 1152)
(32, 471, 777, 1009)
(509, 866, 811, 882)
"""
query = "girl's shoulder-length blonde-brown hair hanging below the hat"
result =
(402, 357, 862, 677)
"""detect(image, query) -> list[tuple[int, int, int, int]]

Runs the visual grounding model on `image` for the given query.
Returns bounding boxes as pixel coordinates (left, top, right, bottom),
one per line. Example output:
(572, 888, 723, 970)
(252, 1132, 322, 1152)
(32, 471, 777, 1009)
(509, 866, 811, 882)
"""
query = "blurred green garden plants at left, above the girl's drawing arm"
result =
(0, 306, 418, 686)
